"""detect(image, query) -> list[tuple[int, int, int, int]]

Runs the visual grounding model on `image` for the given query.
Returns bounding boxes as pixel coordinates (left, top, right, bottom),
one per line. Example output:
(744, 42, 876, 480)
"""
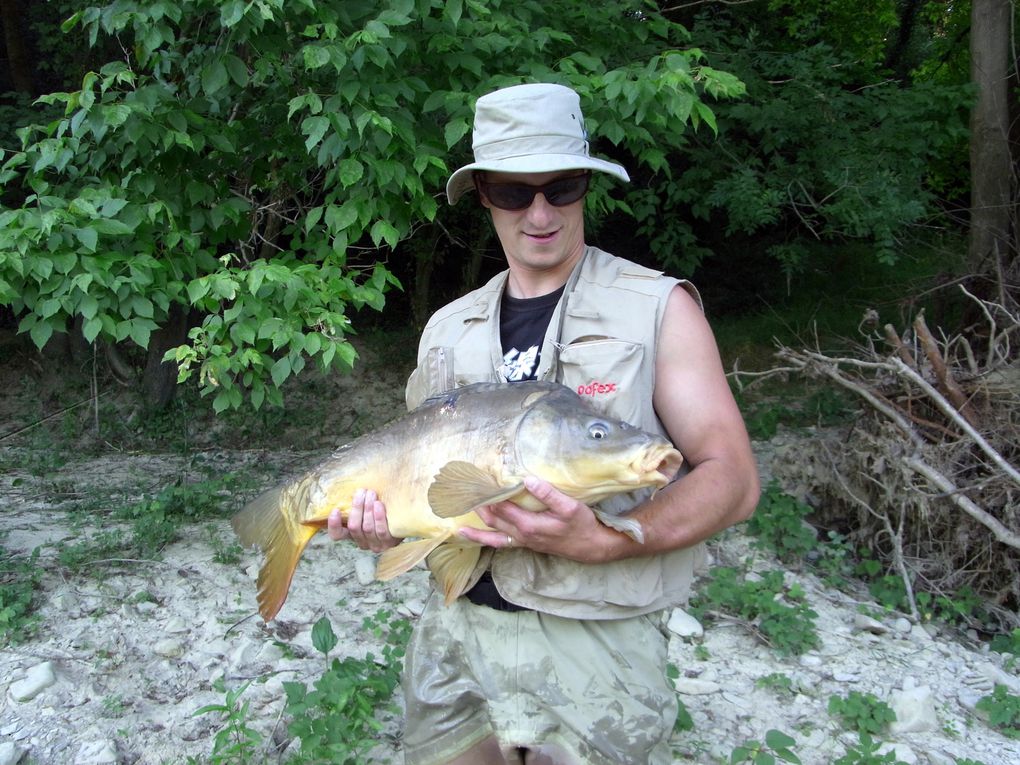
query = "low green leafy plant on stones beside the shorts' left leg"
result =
(284, 611, 410, 765)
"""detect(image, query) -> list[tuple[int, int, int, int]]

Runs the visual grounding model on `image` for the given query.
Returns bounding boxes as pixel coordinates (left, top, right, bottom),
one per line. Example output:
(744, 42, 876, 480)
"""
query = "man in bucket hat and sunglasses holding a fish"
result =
(328, 85, 759, 765)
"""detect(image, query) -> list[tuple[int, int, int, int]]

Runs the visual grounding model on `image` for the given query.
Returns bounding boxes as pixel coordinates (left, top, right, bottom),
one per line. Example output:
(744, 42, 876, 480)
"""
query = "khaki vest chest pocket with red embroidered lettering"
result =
(560, 338, 645, 423)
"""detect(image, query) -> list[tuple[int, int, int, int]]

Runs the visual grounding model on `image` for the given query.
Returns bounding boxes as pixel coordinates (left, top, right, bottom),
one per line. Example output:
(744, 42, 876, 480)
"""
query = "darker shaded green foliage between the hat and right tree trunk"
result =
(631, 11, 971, 278)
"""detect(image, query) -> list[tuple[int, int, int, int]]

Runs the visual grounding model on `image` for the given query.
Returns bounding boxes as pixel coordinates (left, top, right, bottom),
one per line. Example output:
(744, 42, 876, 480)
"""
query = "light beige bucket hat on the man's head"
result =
(447, 83, 630, 205)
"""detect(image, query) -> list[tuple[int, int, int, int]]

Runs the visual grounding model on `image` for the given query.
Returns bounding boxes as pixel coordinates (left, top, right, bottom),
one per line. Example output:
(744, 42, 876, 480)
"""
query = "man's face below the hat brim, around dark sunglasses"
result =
(479, 170, 584, 289)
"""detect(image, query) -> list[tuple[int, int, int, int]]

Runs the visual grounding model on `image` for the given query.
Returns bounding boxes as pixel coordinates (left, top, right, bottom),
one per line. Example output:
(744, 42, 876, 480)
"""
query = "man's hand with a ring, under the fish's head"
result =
(460, 476, 628, 563)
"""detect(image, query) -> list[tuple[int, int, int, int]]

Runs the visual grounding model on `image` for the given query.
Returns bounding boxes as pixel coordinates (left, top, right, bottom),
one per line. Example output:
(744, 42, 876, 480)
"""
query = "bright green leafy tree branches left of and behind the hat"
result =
(0, 0, 742, 411)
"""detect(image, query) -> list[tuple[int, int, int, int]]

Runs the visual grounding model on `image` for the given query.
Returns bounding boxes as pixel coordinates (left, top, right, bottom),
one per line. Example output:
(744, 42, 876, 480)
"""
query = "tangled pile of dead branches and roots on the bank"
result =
(778, 290, 1020, 626)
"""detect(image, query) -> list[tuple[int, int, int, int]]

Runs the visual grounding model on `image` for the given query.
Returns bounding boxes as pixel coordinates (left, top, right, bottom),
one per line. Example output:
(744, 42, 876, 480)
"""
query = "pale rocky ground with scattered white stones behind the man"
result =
(0, 340, 1020, 765)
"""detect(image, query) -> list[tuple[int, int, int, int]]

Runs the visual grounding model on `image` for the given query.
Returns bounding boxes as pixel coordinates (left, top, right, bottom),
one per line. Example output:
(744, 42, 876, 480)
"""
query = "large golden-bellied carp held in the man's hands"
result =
(232, 381, 682, 621)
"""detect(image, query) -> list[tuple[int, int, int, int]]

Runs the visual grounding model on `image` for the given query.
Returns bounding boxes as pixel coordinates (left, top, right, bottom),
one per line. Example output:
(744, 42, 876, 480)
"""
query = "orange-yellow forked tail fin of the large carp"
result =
(231, 488, 319, 621)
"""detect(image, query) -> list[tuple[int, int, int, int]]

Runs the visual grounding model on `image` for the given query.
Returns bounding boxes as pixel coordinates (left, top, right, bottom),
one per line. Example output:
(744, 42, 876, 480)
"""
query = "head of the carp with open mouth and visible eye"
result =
(515, 388, 683, 503)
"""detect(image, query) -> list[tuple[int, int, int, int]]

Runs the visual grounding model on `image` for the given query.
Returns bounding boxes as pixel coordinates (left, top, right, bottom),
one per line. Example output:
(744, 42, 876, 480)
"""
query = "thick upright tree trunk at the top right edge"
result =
(968, 0, 1017, 281)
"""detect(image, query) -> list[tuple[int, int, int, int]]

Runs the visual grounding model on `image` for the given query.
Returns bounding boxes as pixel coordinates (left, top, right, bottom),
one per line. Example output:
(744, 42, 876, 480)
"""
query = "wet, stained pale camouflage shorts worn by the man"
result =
(403, 594, 676, 765)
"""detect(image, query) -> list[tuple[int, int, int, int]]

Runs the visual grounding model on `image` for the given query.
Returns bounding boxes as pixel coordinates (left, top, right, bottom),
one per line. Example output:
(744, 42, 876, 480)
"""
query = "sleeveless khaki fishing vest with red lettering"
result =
(406, 247, 705, 619)
